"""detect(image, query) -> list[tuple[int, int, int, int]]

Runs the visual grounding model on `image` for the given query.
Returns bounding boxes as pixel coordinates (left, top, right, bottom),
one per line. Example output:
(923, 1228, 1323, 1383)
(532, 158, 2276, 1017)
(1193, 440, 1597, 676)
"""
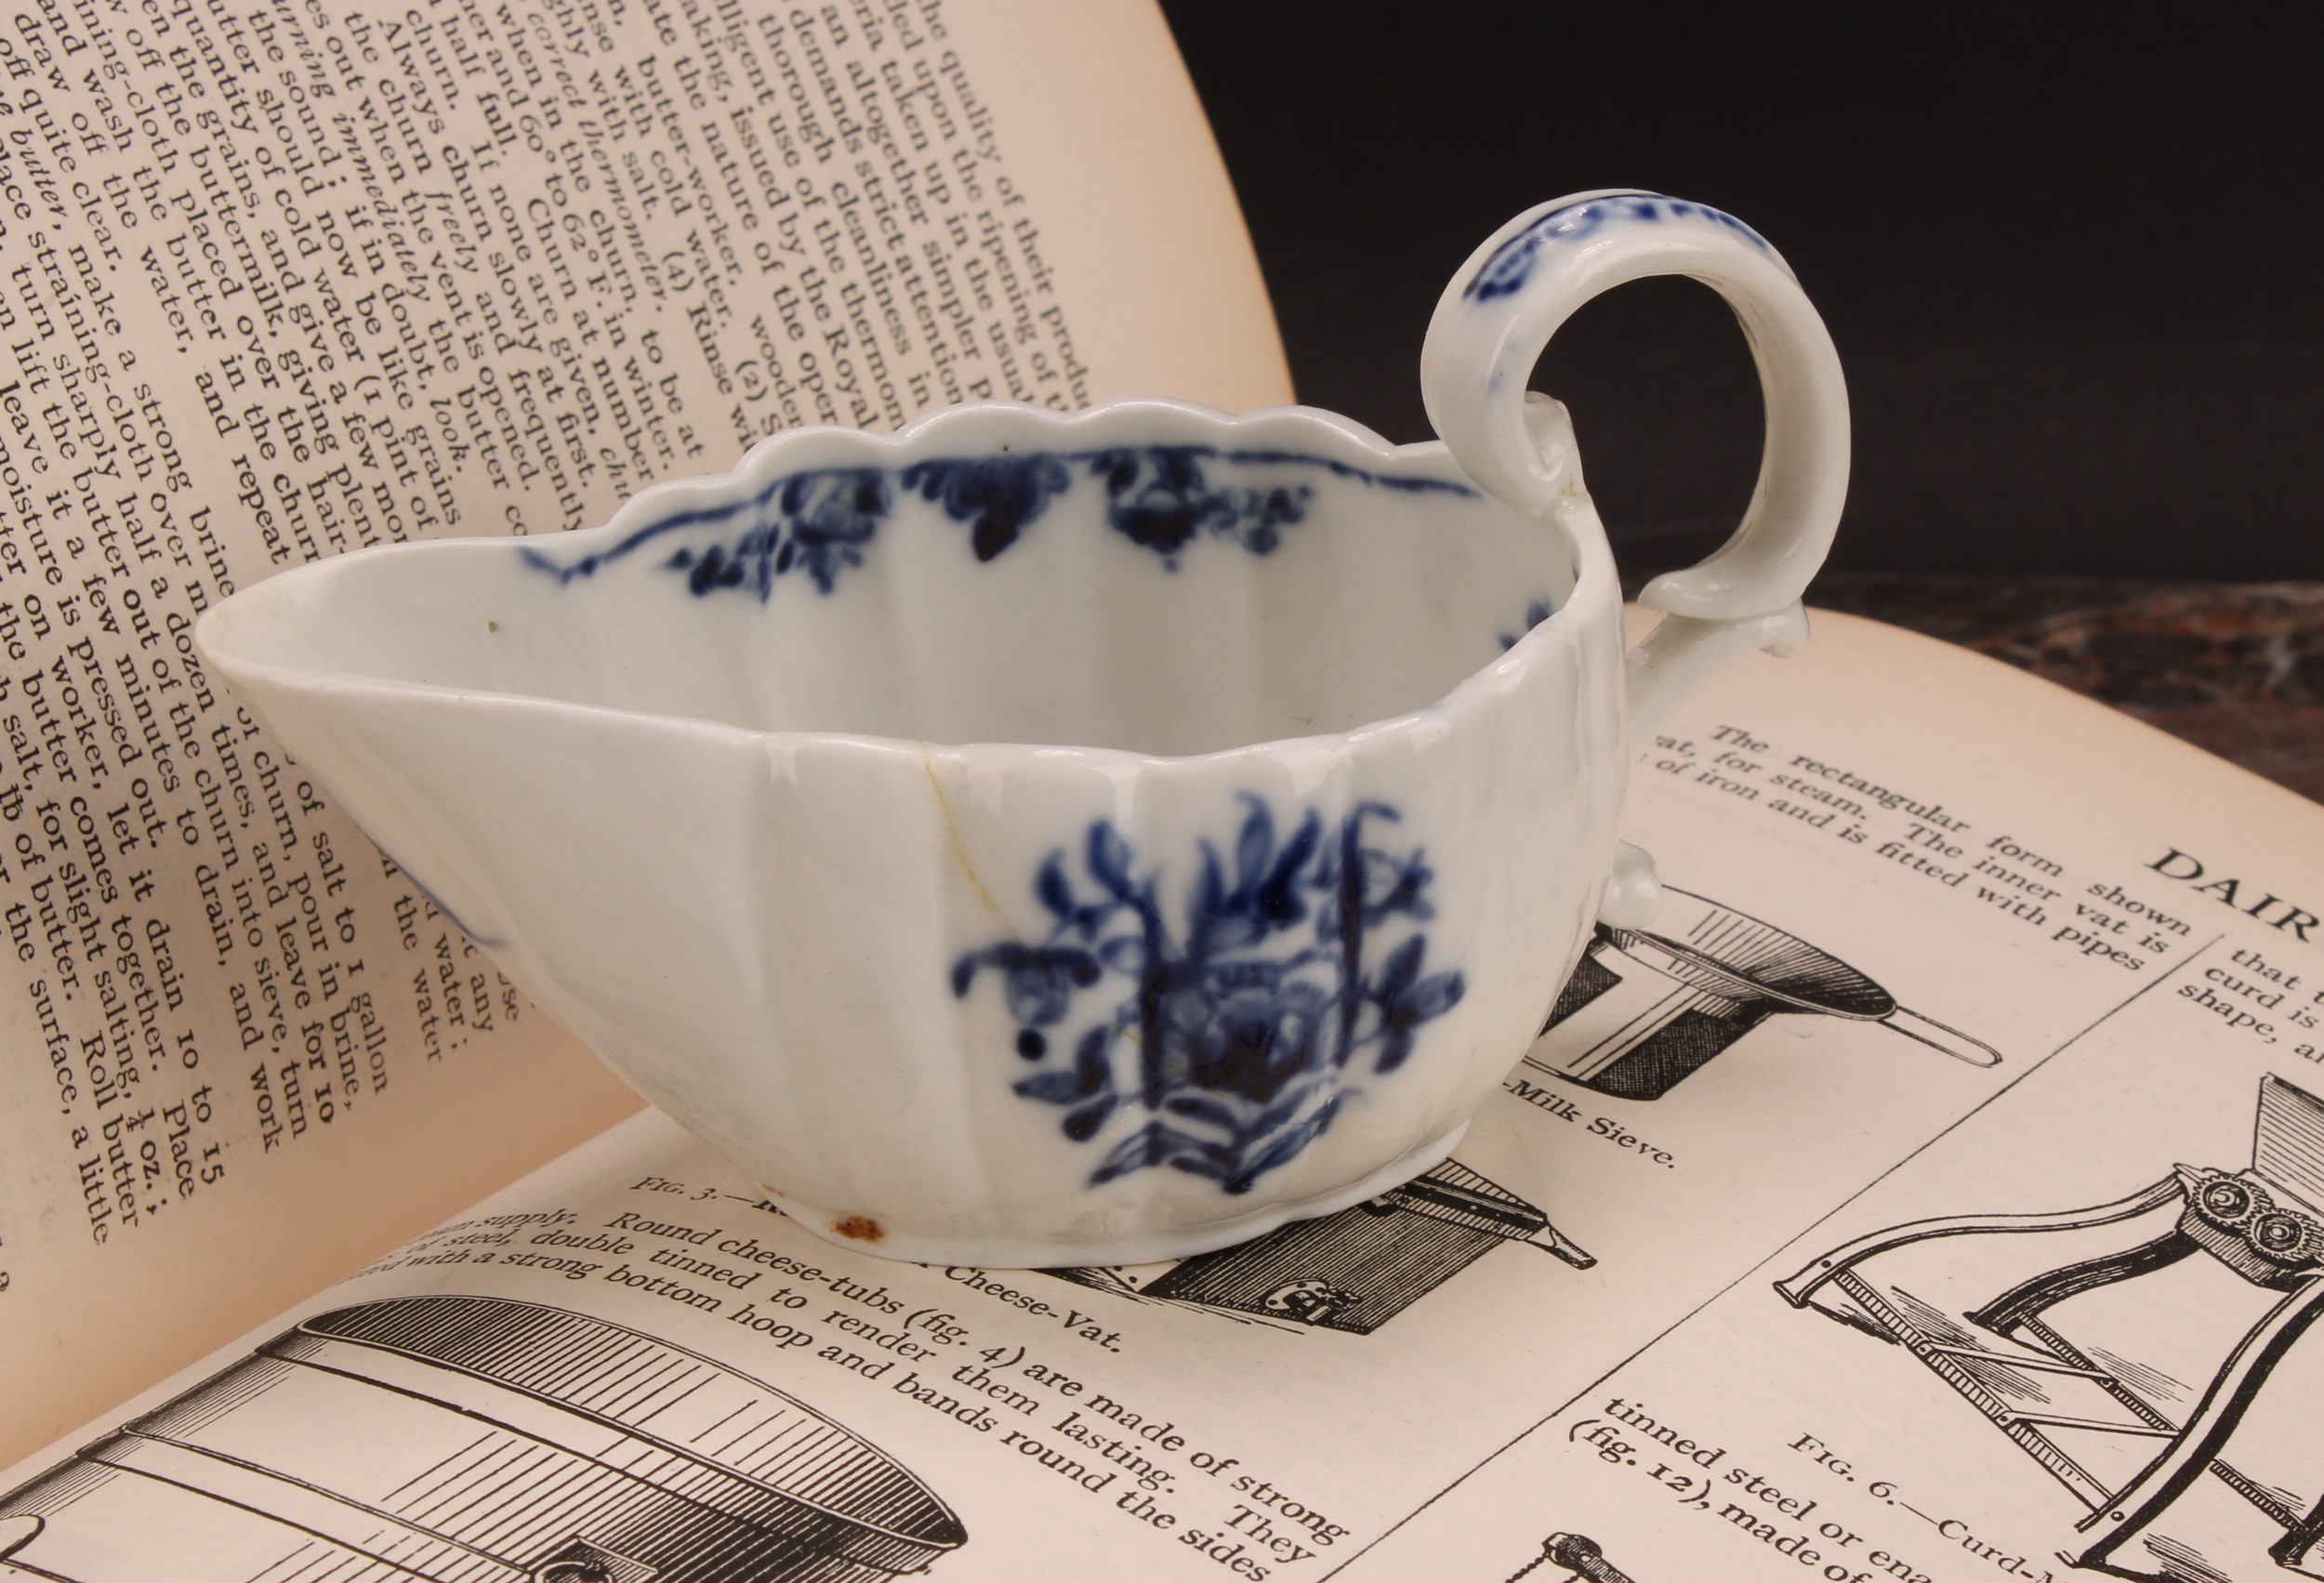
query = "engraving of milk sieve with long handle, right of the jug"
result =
(1525, 886, 2001, 1100)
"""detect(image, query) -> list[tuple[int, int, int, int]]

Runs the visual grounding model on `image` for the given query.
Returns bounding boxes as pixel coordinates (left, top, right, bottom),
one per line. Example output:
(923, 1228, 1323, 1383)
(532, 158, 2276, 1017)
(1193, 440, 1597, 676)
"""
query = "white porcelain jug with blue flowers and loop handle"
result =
(198, 193, 1848, 1264)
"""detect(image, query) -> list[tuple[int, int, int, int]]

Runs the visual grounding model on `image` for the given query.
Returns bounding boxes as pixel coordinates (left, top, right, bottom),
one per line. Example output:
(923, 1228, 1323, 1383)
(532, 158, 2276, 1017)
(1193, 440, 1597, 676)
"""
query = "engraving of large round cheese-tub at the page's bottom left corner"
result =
(0, 1297, 967, 1583)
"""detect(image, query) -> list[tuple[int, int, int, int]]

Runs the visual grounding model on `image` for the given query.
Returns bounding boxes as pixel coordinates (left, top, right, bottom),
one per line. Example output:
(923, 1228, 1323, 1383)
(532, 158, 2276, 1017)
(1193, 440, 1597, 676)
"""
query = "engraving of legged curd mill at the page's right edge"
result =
(1776, 1076, 2324, 1583)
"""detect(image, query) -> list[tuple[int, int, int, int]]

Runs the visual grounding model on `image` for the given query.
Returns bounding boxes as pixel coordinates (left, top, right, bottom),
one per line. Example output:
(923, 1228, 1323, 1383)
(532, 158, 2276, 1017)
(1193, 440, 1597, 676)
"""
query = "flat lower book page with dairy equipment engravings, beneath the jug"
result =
(0, 616, 2324, 1583)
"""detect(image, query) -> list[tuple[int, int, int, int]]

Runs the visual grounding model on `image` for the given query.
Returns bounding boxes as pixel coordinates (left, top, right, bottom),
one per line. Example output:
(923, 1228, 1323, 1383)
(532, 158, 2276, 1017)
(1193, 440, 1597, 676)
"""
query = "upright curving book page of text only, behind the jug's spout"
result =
(0, 0, 1290, 1455)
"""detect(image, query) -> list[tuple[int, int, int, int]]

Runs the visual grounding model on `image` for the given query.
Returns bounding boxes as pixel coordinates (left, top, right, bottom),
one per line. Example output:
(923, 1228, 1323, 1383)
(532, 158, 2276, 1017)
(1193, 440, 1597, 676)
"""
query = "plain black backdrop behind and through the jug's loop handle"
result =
(1162, 0, 2324, 581)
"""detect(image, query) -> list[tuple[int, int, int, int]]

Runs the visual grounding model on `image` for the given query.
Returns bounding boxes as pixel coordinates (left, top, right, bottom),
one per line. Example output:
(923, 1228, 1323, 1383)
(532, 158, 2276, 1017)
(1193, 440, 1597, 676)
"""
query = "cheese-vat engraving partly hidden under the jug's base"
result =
(1049, 1160, 1597, 1334)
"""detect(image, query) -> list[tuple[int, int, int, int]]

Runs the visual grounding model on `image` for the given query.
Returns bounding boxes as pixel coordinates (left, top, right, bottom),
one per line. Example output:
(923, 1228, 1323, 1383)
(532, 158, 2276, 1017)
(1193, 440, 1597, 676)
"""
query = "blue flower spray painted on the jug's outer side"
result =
(953, 795, 1467, 1193)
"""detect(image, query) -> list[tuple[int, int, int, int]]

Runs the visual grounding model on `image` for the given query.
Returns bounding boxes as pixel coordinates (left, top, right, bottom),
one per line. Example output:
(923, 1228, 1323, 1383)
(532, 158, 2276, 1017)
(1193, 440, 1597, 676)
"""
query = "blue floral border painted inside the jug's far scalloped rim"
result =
(521, 444, 1478, 600)
